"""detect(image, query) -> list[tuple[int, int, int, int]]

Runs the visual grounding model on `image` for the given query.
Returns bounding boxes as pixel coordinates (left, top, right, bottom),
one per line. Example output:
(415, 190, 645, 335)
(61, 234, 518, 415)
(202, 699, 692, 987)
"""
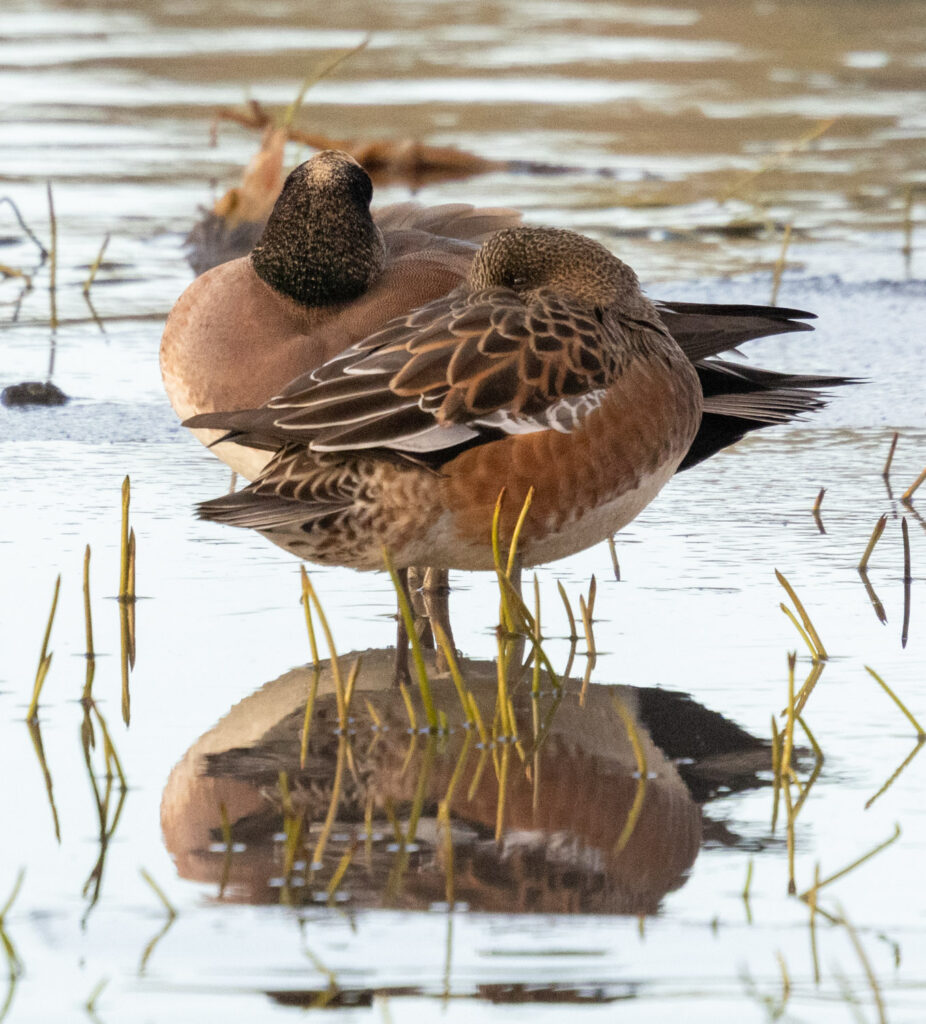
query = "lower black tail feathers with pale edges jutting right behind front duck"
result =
(678, 359, 859, 472)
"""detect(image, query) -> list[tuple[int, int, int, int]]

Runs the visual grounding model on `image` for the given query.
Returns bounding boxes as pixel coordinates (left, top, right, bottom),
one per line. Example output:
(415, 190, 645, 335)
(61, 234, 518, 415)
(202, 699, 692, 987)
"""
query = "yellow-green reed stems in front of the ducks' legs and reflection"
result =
(214, 495, 618, 906)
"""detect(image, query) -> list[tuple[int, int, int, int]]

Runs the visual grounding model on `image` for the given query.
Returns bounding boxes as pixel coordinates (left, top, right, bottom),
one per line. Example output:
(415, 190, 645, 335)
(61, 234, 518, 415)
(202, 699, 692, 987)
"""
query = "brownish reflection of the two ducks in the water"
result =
(162, 650, 770, 914)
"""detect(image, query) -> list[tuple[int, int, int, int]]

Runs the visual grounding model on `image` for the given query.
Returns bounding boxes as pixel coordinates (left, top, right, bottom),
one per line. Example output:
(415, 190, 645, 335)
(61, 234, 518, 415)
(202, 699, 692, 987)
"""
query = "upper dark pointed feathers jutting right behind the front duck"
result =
(657, 302, 816, 362)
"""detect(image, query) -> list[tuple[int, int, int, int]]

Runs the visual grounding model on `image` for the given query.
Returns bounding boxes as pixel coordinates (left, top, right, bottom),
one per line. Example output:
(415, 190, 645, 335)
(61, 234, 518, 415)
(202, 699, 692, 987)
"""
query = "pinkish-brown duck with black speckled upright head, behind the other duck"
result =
(161, 152, 520, 479)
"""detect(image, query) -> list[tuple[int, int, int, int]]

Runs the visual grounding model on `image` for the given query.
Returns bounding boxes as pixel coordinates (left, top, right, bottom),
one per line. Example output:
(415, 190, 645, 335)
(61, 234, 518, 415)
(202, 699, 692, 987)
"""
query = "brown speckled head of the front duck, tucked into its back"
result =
(469, 226, 655, 314)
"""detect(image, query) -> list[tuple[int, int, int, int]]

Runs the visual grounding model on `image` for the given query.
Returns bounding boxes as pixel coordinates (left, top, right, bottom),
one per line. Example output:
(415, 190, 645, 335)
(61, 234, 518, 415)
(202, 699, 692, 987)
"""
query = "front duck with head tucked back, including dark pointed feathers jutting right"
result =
(187, 227, 844, 569)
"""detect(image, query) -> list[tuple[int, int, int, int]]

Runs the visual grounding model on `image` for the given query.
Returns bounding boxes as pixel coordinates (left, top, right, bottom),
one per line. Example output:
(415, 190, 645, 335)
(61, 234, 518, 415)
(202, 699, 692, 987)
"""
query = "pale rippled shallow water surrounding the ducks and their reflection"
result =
(0, 0, 926, 1022)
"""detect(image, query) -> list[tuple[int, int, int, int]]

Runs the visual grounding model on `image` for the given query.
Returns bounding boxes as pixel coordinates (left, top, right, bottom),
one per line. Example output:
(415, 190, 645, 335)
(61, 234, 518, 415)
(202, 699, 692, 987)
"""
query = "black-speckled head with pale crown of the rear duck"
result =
(251, 150, 385, 307)
